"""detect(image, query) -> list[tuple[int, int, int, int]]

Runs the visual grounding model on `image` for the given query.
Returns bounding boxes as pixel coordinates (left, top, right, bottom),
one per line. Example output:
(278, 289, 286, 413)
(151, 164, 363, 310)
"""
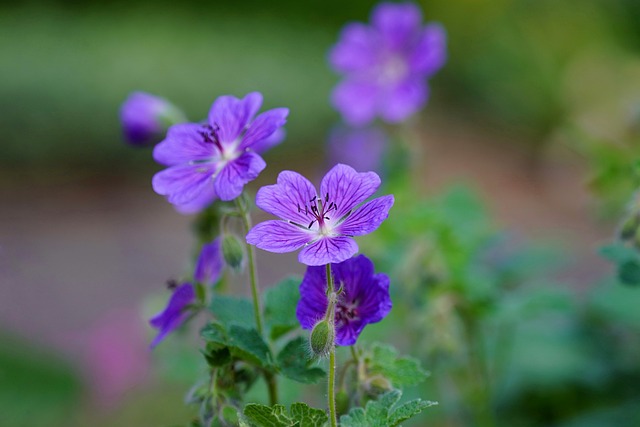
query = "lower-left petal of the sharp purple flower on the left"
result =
(152, 163, 215, 205)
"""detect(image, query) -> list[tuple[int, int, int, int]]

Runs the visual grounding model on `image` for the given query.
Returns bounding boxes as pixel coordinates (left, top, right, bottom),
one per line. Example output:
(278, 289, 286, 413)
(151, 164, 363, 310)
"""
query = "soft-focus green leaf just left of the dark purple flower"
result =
(264, 276, 302, 340)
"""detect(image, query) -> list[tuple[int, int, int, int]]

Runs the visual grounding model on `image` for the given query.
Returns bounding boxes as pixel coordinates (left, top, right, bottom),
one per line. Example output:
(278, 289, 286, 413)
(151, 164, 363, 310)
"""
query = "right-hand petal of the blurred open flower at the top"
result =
(409, 24, 447, 77)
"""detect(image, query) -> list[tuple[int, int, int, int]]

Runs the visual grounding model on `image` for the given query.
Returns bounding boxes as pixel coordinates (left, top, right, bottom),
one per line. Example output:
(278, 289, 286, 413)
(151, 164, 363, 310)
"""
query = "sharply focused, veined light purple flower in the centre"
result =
(247, 164, 393, 265)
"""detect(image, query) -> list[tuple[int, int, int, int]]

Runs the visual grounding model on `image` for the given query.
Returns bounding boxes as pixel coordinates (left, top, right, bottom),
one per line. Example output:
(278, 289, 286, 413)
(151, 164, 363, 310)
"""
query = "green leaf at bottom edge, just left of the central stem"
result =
(241, 403, 328, 427)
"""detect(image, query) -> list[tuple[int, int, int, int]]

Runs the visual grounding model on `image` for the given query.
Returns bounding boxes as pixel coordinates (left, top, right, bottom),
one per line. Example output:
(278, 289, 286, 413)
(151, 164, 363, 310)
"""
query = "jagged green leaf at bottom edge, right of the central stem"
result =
(340, 390, 437, 427)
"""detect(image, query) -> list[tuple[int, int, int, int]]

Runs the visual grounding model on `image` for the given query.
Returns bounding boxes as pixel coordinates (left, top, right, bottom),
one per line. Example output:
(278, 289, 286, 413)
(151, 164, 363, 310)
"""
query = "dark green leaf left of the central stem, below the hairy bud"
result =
(277, 337, 326, 384)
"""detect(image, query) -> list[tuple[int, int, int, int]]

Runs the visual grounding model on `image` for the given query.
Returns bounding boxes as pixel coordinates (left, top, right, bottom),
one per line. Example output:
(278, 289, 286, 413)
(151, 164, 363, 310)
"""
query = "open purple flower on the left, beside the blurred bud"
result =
(153, 92, 289, 208)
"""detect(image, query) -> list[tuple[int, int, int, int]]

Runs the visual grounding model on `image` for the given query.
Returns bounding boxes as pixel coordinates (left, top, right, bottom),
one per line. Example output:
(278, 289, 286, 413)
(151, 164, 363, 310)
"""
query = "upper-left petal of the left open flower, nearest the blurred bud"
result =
(153, 123, 218, 166)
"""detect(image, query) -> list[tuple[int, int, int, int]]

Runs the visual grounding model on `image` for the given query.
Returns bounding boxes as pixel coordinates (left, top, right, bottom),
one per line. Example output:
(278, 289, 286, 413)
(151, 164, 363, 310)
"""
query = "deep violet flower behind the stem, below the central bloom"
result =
(296, 255, 391, 345)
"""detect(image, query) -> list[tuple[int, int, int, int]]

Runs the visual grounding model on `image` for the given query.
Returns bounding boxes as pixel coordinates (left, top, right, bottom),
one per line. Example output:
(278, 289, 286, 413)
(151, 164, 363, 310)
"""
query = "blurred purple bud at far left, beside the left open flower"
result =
(120, 92, 186, 145)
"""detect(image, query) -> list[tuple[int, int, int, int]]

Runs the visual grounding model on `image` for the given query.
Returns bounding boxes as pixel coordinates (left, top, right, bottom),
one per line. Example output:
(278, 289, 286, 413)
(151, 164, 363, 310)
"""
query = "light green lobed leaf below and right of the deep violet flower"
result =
(368, 343, 429, 388)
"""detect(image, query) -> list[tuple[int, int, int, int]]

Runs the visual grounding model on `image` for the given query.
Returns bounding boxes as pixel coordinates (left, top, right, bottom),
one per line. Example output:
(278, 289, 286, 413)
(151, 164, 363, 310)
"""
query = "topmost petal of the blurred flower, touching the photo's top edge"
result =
(371, 3, 422, 49)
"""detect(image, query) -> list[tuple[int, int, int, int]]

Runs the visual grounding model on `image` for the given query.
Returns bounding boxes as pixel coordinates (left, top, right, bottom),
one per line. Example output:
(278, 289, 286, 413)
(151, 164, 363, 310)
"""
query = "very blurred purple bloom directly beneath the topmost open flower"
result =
(328, 127, 387, 172)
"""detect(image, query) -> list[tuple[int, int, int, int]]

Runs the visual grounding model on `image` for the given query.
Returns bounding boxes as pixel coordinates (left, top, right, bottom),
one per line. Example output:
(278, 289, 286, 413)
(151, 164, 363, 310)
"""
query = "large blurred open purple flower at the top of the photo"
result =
(329, 3, 446, 126)
